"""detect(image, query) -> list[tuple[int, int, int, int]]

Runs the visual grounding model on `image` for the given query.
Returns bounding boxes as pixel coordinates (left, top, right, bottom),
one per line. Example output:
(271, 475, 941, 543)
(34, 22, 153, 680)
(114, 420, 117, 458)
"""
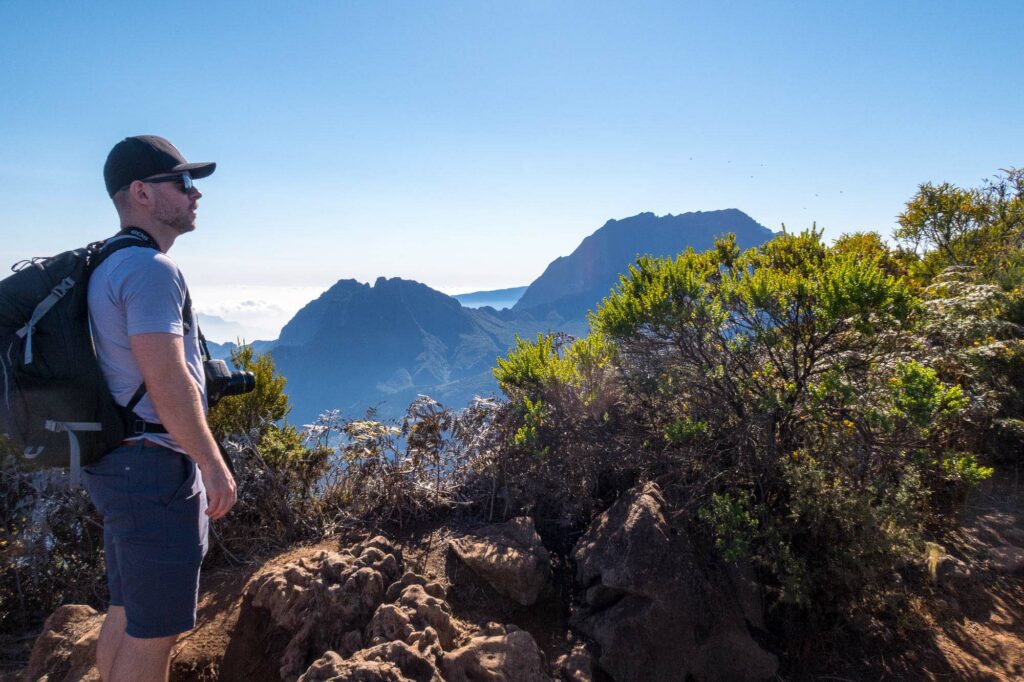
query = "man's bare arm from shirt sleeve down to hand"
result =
(129, 334, 236, 519)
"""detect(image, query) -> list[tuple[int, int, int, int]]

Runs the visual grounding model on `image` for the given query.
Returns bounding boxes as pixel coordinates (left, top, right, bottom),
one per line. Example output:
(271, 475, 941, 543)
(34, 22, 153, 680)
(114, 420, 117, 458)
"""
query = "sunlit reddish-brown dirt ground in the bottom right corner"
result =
(782, 468, 1024, 682)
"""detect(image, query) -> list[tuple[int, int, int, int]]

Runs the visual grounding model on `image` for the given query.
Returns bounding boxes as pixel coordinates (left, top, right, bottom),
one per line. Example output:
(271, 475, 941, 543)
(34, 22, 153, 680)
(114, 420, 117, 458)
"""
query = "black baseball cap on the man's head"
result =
(103, 135, 217, 197)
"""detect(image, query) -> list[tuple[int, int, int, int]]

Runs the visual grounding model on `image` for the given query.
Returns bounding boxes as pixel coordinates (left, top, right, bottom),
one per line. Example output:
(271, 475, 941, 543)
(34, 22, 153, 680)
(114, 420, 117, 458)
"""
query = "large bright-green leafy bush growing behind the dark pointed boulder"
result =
(493, 224, 1016, 614)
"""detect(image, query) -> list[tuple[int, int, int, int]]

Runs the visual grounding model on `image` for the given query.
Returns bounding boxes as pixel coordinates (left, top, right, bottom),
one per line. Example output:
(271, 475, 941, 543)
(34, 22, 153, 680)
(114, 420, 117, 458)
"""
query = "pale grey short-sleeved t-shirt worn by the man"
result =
(89, 238, 206, 453)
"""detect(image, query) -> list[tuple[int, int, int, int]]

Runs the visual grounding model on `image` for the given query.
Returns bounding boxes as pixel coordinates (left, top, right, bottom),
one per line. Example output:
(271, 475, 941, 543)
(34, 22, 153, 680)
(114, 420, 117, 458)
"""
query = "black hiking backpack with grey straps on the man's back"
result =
(0, 227, 166, 486)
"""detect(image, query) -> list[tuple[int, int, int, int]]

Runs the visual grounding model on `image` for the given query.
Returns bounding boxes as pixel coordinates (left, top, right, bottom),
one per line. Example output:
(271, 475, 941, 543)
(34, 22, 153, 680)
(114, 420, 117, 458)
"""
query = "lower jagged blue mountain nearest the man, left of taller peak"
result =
(271, 278, 540, 422)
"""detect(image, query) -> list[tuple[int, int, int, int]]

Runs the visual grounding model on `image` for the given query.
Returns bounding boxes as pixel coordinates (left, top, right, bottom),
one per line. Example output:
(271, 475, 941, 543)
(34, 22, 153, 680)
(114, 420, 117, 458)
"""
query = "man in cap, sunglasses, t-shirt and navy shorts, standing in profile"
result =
(83, 135, 236, 682)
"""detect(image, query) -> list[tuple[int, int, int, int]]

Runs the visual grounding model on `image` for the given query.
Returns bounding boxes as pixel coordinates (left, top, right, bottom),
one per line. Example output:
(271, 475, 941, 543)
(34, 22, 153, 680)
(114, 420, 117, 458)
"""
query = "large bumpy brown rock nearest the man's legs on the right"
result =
(221, 538, 403, 682)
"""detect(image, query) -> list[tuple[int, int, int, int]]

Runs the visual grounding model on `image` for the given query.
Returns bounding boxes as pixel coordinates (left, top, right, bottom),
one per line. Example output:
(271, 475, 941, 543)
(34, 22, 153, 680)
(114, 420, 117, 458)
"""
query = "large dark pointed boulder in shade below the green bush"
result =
(571, 483, 778, 682)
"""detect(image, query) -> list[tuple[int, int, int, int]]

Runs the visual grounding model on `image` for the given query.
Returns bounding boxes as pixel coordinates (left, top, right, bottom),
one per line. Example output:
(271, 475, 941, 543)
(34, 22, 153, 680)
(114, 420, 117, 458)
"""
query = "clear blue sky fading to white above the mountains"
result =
(0, 0, 1024, 336)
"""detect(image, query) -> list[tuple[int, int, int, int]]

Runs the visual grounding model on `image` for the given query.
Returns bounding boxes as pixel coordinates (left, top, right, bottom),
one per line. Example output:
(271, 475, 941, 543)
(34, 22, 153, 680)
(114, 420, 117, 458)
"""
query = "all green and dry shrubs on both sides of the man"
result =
(0, 170, 1024, 659)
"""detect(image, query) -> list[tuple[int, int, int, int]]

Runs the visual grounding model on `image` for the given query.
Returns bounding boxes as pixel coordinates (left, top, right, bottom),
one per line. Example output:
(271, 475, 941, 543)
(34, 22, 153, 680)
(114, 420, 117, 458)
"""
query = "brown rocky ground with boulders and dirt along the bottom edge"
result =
(7, 473, 1024, 682)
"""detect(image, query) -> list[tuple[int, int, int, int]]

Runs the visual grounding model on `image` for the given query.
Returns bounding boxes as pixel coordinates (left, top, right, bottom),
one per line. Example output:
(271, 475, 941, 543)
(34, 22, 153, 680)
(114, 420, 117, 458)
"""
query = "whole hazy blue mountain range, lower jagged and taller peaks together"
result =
(270, 209, 773, 423)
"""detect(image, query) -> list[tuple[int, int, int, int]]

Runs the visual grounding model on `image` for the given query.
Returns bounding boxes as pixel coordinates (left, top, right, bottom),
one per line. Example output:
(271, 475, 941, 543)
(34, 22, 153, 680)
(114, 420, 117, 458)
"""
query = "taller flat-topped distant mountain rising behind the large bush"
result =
(513, 209, 774, 319)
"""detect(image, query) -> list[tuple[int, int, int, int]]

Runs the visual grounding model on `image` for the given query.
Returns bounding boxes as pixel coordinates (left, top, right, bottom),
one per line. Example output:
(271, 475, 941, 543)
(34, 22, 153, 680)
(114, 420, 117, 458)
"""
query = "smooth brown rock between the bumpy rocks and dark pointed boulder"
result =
(450, 517, 551, 606)
